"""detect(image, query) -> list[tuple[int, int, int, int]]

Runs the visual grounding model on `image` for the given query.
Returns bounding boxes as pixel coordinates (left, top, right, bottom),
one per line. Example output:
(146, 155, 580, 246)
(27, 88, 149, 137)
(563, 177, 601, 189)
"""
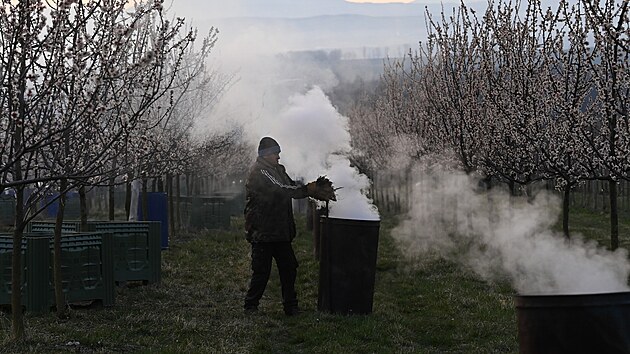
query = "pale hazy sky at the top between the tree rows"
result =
(165, 0, 466, 52)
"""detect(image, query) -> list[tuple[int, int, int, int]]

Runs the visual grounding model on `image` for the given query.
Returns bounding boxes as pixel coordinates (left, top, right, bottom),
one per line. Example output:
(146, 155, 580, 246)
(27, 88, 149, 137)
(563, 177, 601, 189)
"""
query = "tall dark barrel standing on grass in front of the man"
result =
(317, 216, 380, 314)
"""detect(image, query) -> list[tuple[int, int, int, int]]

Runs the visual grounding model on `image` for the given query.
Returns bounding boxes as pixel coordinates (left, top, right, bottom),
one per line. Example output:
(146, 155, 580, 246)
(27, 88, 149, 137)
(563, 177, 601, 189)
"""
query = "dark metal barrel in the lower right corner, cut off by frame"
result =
(515, 292, 630, 354)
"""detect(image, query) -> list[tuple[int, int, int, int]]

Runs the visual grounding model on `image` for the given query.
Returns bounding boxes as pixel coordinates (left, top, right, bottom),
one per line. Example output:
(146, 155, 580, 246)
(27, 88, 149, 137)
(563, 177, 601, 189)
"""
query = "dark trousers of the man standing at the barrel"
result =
(245, 241, 298, 310)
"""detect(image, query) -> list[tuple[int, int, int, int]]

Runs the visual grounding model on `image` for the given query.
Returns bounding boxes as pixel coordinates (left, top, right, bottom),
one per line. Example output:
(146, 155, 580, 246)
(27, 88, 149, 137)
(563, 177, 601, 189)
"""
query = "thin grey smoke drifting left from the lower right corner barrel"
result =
(392, 165, 630, 294)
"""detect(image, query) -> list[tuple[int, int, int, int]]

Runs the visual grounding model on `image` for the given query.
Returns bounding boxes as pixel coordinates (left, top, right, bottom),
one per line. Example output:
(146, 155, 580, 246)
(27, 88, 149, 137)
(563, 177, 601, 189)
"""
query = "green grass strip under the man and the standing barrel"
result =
(0, 212, 629, 353)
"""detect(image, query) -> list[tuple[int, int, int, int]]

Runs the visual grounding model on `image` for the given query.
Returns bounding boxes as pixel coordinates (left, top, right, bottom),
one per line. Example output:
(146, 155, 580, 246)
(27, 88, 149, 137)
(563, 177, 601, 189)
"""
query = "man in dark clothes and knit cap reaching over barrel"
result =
(244, 137, 335, 316)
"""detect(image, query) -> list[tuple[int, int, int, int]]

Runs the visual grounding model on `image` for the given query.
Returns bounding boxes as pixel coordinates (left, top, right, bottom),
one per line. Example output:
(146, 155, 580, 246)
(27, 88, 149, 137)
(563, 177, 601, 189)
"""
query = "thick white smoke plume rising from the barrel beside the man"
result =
(189, 1, 379, 220)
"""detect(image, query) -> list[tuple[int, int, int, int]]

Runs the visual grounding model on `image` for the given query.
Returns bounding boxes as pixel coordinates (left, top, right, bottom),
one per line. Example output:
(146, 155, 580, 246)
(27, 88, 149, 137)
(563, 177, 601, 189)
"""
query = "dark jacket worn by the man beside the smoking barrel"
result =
(244, 157, 307, 242)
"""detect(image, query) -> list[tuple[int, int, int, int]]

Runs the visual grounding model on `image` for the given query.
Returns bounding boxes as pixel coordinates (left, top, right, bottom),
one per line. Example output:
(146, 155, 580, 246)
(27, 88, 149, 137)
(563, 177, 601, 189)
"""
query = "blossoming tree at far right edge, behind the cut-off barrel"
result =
(575, 0, 630, 249)
